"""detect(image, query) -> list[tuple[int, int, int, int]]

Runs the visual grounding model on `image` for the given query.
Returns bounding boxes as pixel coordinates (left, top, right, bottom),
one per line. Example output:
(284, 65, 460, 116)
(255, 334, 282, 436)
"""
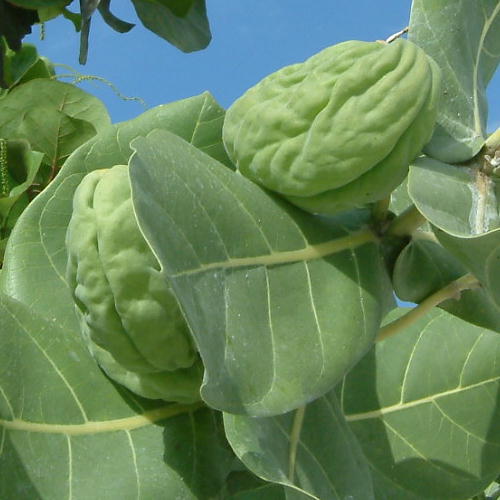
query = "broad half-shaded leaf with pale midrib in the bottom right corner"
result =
(338, 310, 500, 500)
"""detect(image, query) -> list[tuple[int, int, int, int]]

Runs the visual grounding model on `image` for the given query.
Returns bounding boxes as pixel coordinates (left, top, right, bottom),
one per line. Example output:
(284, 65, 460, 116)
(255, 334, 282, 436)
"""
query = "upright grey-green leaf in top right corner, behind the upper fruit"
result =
(409, 0, 500, 163)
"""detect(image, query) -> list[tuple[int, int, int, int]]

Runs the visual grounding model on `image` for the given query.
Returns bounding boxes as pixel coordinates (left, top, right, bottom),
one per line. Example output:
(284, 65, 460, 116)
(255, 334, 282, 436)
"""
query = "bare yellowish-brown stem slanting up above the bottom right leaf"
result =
(376, 274, 480, 342)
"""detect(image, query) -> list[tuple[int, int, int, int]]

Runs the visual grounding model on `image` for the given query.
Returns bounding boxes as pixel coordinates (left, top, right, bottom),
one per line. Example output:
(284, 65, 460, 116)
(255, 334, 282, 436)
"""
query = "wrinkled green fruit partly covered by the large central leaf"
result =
(66, 165, 203, 403)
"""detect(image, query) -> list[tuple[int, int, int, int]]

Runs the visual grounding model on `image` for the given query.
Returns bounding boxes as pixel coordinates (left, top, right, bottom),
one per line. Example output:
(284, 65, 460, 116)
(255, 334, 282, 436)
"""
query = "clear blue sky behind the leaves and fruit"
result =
(25, 0, 500, 130)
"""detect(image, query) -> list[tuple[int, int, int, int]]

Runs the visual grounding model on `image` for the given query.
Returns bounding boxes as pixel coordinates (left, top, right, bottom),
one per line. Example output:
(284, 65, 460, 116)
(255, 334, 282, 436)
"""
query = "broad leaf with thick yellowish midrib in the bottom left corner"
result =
(0, 289, 234, 500)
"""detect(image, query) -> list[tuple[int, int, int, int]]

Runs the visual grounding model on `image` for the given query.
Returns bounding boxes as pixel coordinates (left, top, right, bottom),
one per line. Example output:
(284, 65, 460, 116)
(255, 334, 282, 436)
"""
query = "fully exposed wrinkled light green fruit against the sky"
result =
(223, 39, 440, 214)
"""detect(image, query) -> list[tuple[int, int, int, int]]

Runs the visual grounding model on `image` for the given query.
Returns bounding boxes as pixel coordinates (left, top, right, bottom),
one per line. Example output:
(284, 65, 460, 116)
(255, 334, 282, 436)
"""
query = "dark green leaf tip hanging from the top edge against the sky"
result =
(132, 0, 212, 52)
